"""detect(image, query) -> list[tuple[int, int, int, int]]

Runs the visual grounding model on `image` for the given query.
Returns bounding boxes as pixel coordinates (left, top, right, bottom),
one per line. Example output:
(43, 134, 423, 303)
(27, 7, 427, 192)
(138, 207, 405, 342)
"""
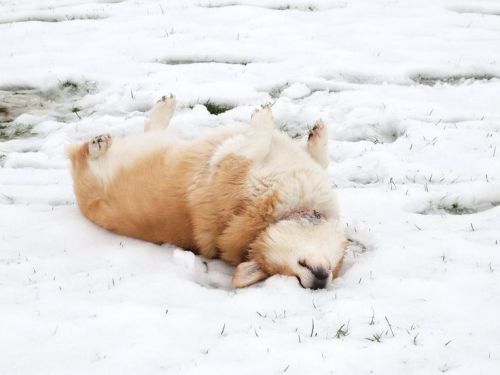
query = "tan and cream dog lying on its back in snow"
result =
(68, 96, 346, 289)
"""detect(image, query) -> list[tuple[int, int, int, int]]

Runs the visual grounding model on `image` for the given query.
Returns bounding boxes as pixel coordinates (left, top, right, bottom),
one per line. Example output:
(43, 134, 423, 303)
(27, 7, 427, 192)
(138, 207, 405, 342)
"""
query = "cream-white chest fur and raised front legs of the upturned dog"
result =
(210, 107, 339, 219)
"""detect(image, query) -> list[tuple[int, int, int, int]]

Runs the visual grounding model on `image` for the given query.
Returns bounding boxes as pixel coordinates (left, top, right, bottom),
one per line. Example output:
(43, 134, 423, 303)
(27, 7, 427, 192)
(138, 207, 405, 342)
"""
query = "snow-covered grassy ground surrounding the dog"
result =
(0, 0, 500, 375)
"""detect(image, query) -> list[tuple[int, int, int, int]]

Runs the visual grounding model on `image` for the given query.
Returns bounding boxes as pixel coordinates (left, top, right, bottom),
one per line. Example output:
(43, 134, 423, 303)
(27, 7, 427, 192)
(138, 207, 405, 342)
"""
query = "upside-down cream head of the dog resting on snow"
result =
(233, 218, 347, 289)
